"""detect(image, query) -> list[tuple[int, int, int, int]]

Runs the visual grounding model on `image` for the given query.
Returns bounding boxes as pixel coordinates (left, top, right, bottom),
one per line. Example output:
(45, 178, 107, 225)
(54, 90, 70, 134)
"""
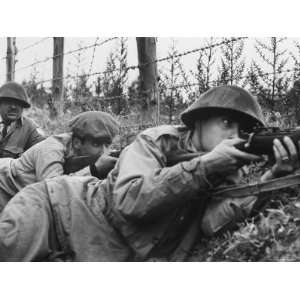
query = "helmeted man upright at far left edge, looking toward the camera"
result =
(0, 82, 45, 158)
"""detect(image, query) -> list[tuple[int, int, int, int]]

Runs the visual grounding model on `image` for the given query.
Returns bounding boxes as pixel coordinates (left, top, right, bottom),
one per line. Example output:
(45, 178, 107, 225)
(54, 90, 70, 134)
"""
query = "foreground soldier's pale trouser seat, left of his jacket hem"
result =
(0, 183, 55, 261)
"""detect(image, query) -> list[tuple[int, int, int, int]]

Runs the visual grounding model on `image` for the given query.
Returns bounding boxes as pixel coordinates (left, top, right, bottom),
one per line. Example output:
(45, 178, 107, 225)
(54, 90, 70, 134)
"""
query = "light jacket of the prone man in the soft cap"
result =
(0, 133, 90, 210)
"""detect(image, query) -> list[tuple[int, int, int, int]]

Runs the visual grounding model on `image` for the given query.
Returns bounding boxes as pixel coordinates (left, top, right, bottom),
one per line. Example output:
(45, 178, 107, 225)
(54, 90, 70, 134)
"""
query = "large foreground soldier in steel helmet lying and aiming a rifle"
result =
(0, 86, 298, 261)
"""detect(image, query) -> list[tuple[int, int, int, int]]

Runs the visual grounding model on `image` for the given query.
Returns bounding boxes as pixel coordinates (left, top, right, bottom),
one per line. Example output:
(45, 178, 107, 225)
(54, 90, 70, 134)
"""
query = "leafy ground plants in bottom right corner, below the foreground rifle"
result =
(189, 188, 300, 261)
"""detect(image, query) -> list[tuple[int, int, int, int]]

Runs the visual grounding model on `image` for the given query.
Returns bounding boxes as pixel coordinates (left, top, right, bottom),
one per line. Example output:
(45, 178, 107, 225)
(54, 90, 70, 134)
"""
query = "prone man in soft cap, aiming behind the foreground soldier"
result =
(0, 111, 118, 211)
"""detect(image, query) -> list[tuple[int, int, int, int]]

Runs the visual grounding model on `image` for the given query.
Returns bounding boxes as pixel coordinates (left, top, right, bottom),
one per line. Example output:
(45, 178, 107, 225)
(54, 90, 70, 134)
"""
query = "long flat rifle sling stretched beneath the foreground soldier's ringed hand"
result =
(212, 174, 300, 198)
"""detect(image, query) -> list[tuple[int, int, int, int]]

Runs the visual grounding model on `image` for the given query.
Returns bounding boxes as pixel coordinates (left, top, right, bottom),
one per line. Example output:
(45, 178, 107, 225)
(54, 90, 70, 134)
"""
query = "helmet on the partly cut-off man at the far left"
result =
(0, 81, 30, 108)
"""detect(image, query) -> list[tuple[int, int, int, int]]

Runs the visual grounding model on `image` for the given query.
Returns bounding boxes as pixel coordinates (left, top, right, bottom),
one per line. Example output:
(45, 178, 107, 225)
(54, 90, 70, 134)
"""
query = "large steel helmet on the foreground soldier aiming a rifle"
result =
(181, 85, 265, 129)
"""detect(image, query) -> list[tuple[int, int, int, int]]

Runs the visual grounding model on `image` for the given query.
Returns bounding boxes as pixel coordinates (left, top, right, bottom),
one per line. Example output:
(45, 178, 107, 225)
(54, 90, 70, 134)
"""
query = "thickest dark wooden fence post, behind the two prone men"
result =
(136, 37, 159, 124)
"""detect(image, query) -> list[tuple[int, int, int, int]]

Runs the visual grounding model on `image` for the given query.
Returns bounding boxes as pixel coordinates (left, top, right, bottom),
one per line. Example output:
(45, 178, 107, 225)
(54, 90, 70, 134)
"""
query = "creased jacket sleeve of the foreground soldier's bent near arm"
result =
(113, 134, 209, 221)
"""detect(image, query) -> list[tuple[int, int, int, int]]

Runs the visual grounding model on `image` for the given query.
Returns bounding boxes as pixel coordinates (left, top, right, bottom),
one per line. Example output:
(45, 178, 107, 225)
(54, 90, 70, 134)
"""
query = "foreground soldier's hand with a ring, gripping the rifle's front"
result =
(271, 136, 300, 178)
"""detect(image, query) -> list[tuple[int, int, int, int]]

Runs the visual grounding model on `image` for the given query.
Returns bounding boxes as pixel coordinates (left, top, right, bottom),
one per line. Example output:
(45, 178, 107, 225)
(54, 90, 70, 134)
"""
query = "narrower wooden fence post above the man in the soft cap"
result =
(50, 37, 64, 117)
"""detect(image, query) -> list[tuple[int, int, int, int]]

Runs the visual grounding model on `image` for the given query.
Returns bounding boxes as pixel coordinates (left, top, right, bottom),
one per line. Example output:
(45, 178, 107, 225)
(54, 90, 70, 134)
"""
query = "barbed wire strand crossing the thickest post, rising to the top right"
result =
(32, 37, 248, 84)
